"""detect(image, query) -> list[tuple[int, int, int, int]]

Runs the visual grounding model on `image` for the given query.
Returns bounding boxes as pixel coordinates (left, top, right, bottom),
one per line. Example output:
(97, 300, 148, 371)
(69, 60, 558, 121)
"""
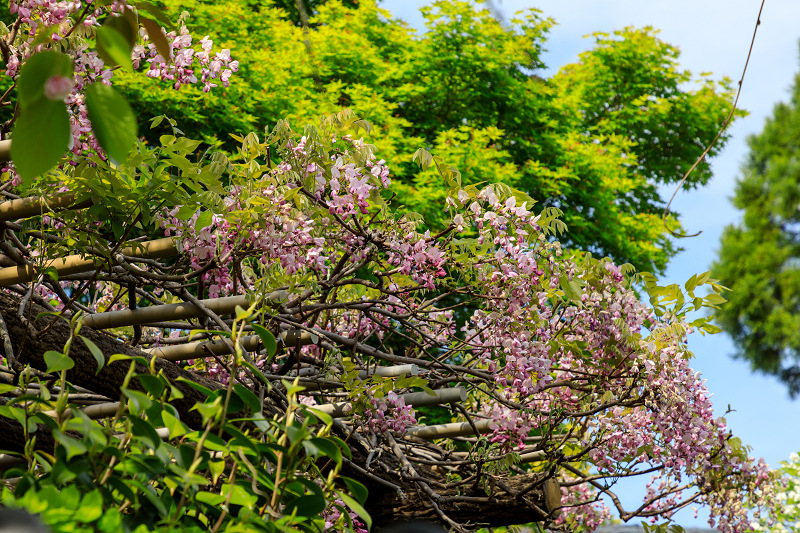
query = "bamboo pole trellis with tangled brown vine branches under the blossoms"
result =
(0, 141, 561, 526)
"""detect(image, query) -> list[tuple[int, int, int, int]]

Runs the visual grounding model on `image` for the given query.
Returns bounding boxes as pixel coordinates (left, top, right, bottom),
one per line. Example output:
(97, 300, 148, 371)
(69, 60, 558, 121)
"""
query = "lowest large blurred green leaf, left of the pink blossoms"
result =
(11, 98, 71, 186)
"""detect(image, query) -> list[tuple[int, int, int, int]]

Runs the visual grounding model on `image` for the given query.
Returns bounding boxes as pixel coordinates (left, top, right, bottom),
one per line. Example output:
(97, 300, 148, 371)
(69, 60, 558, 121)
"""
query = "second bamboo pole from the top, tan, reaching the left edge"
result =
(0, 237, 178, 287)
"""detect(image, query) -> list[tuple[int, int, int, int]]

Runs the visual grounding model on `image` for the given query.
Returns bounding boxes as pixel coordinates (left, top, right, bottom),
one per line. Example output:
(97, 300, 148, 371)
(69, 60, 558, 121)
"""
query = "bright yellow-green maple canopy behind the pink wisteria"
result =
(115, 0, 731, 272)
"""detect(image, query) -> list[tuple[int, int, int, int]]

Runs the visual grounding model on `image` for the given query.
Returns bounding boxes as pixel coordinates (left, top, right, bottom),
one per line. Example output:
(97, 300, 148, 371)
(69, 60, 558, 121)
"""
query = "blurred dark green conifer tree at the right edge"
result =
(714, 68, 800, 396)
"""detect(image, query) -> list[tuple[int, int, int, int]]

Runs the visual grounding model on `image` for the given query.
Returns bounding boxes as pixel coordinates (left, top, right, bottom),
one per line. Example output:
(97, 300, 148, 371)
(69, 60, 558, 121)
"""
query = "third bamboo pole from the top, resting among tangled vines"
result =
(83, 290, 287, 330)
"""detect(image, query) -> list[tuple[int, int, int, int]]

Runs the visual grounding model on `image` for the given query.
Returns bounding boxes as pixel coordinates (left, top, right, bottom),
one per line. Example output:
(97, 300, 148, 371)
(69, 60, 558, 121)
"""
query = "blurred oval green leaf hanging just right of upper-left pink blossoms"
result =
(86, 83, 137, 163)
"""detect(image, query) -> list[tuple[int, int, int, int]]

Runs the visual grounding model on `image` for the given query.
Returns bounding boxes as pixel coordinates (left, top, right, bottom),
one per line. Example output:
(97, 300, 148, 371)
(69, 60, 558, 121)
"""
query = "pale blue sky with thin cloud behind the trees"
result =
(382, 0, 800, 527)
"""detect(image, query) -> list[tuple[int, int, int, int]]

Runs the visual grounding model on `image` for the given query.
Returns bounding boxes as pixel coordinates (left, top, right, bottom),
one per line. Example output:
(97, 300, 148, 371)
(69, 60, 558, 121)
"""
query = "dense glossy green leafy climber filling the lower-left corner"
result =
(0, 309, 370, 533)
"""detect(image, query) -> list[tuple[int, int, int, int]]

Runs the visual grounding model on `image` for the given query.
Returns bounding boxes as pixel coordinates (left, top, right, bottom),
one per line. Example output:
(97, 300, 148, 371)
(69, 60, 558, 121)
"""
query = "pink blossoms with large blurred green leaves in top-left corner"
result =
(0, 0, 238, 185)
